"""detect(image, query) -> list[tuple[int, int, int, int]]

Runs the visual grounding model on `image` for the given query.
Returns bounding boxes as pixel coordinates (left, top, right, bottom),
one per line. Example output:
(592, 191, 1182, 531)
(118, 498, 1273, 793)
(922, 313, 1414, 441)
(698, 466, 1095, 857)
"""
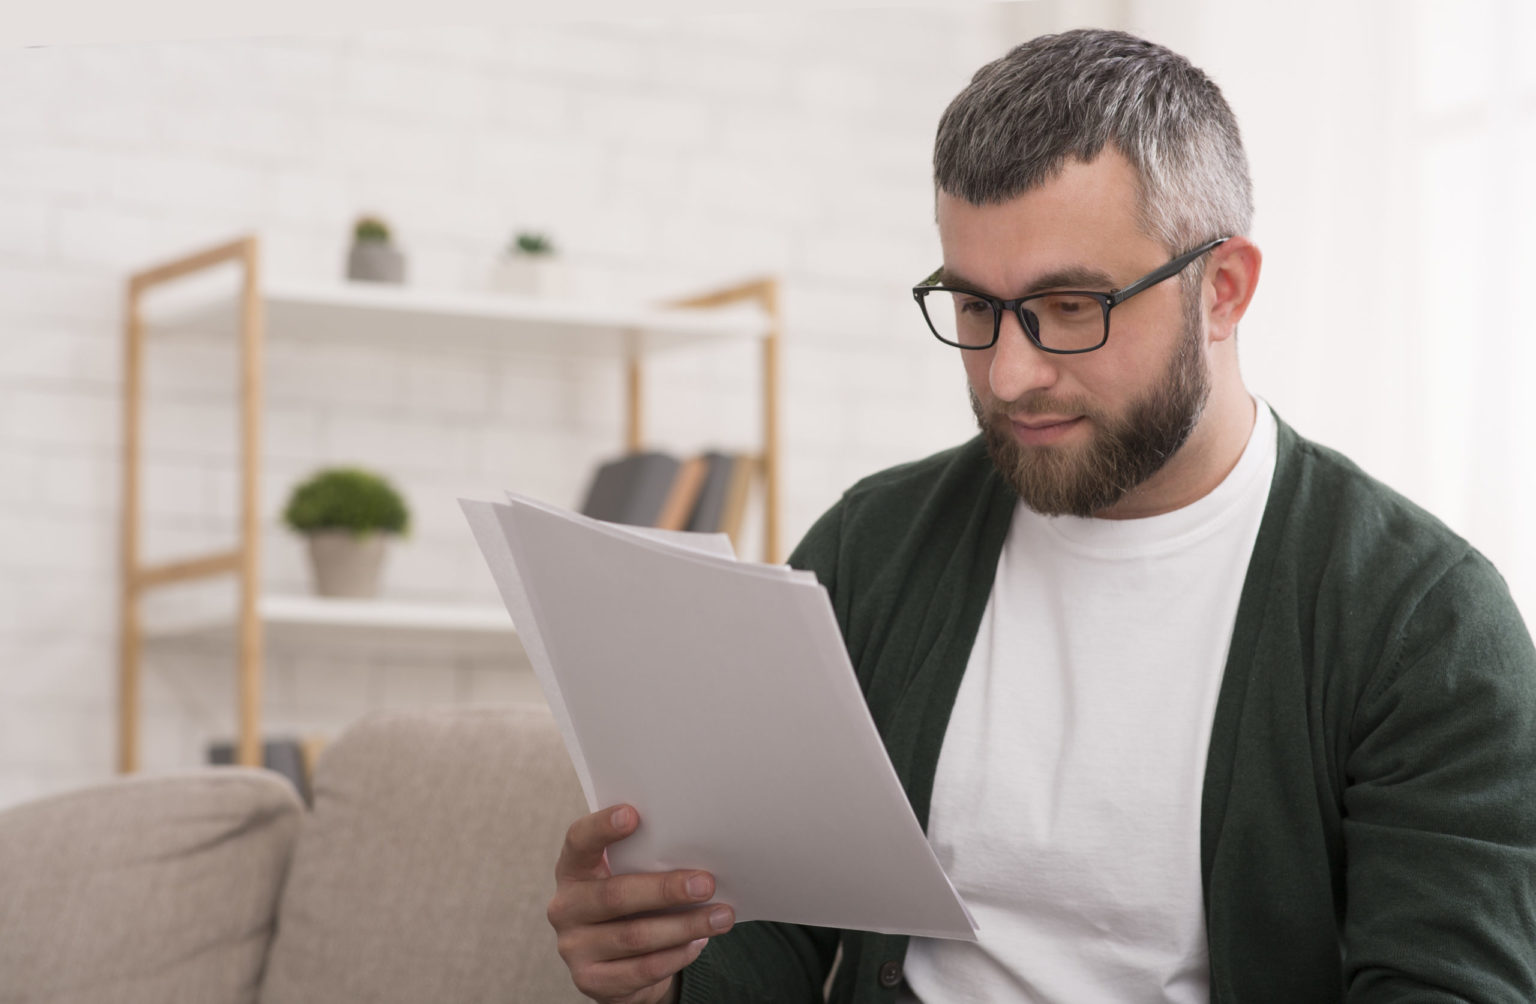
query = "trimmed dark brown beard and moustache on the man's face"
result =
(971, 312, 1210, 516)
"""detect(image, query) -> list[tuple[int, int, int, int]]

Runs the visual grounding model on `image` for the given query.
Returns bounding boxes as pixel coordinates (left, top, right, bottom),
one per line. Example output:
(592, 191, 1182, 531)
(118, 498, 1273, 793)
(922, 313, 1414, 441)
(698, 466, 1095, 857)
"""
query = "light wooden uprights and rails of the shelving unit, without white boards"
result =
(118, 235, 780, 774)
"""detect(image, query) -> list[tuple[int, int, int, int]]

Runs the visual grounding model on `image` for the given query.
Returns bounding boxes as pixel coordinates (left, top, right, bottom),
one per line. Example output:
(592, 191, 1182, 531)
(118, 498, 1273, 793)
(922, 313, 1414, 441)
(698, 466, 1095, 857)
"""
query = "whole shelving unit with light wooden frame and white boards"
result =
(118, 235, 780, 774)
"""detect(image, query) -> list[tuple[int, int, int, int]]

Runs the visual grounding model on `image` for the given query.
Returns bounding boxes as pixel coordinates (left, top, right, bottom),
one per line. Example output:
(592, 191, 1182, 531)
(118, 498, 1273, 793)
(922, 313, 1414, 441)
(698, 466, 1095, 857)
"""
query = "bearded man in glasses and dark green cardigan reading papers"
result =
(548, 31, 1536, 1004)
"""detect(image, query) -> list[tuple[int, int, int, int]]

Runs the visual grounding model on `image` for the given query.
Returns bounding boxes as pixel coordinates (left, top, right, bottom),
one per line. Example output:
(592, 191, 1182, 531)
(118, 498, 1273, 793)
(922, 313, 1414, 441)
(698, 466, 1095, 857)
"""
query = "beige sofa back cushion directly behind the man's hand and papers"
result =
(261, 706, 587, 1004)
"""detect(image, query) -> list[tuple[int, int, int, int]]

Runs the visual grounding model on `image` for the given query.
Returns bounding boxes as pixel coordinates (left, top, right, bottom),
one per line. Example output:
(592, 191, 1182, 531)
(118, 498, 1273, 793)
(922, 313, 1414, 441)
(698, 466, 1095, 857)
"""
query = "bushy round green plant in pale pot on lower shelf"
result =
(283, 467, 410, 597)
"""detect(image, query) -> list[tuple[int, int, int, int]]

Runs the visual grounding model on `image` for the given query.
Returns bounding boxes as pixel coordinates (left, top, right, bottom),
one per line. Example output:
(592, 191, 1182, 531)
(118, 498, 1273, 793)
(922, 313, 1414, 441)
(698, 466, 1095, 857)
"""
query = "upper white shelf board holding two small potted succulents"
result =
(144, 279, 768, 355)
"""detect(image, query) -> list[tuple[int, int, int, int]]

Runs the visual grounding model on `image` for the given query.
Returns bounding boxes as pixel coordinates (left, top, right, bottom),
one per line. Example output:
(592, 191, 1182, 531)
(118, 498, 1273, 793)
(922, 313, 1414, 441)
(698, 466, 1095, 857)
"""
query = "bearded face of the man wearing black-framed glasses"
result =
(938, 149, 1210, 516)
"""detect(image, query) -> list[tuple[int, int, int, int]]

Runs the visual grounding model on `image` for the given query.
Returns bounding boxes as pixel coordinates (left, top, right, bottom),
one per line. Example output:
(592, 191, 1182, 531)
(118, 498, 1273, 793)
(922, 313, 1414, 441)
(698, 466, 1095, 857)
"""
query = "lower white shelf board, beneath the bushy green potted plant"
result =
(144, 594, 518, 651)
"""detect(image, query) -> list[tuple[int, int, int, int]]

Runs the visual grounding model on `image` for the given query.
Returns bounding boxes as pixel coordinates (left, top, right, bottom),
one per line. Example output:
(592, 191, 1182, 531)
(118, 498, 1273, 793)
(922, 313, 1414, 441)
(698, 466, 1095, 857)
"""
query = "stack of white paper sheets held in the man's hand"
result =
(464, 497, 975, 940)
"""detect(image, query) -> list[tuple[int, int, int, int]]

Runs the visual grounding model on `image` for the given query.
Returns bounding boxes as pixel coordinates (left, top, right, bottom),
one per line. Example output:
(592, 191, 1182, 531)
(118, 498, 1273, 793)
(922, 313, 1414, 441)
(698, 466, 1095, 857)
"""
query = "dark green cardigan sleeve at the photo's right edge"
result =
(1342, 551, 1536, 1004)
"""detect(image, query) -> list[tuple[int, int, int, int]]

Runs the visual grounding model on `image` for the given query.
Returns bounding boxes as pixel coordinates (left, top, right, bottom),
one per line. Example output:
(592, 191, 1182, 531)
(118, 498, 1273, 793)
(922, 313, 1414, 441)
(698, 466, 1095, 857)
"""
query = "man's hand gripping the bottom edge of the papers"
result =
(548, 806, 736, 1004)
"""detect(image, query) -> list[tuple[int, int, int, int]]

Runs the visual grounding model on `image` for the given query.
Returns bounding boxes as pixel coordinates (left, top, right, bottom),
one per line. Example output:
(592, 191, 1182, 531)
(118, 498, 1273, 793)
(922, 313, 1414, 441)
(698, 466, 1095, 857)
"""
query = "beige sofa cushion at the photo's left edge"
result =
(0, 768, 303, 1004)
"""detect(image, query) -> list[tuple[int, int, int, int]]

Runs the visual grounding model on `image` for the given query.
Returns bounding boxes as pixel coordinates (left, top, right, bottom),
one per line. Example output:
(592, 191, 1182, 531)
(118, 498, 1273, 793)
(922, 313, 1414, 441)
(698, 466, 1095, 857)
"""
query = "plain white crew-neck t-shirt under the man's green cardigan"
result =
(906, 402, 1276, 1004)
